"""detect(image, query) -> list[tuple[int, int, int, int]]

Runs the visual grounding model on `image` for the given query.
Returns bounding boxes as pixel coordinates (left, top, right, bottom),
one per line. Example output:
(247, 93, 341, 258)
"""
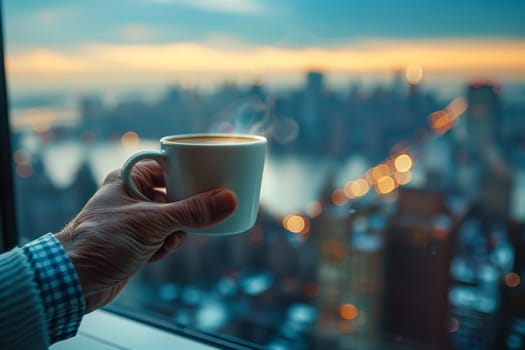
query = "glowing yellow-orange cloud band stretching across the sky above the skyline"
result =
(7, 39, 525, 89)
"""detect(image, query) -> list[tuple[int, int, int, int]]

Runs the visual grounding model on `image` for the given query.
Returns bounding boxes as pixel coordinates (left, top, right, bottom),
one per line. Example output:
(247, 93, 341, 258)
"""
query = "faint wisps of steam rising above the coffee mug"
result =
(210, 98, 299, 144)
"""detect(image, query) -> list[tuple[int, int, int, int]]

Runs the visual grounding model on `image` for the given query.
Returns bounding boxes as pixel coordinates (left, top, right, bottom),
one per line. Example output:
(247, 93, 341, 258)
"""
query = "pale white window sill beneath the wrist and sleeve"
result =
(50, 310, 216, 350)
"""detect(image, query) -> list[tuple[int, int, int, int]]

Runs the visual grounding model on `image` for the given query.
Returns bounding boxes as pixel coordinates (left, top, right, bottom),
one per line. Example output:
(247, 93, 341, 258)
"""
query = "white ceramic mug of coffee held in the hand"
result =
(121, 134, 266, 235)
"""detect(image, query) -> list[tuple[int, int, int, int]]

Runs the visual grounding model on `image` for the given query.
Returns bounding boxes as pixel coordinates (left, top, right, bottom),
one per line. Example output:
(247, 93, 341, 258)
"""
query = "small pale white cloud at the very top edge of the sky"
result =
(150, 0, 266, 15)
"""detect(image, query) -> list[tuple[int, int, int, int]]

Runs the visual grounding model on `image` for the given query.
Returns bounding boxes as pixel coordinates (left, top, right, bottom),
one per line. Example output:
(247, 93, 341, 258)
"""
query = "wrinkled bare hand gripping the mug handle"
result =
(56, 162, 237, 312)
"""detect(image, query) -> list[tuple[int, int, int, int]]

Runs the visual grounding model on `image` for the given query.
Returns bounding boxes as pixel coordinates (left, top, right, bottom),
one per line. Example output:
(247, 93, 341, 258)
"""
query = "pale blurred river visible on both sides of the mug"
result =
(34, 140, 369, 214)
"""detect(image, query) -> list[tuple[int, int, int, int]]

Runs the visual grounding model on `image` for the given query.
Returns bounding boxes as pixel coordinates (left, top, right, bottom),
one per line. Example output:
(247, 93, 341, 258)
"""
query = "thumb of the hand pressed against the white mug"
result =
(157, 189, 237, 232)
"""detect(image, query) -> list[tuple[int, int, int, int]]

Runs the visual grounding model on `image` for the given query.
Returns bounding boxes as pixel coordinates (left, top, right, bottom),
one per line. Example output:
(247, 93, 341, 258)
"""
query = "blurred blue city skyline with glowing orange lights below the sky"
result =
(12, 64, 525, 349)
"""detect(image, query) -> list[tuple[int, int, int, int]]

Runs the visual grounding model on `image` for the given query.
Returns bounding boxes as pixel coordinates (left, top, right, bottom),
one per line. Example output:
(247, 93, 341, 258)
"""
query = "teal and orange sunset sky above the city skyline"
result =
(3, 0, 525, 94)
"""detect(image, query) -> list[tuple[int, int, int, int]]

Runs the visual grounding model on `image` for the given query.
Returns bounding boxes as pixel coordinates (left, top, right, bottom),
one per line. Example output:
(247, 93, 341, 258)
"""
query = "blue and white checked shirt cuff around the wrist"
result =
(22, 233, 86, 344)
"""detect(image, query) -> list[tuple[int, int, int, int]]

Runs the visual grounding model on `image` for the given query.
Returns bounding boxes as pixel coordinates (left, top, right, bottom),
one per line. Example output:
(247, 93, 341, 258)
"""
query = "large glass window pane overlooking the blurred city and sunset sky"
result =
(4, 0, 525, 349)
